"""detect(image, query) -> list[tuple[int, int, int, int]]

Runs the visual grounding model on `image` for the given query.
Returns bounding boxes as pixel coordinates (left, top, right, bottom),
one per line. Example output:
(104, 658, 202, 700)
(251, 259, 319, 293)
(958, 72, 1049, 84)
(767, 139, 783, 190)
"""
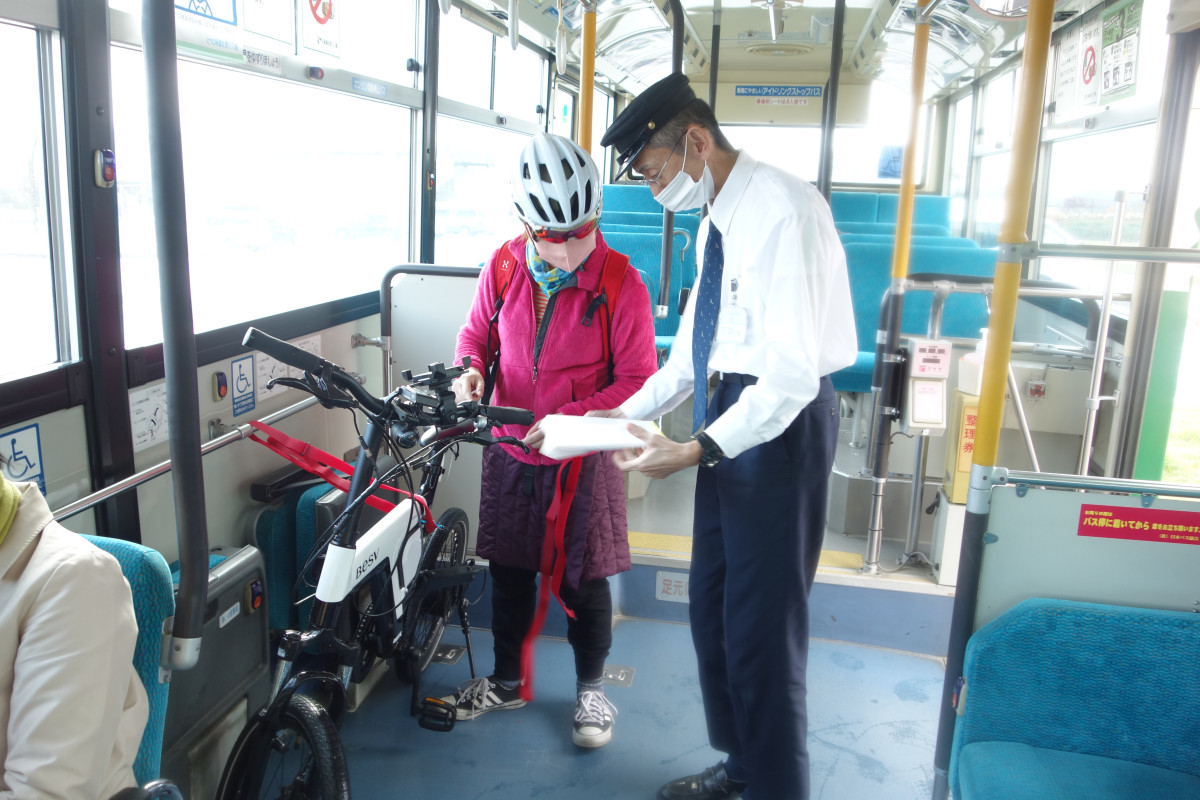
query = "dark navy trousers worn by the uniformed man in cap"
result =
(689, 375, 838, 800)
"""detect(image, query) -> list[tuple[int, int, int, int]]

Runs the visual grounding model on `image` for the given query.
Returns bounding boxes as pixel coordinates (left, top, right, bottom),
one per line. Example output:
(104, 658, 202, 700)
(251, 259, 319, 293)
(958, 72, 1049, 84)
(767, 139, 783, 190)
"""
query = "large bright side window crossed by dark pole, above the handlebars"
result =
(112, 47, 412, 347)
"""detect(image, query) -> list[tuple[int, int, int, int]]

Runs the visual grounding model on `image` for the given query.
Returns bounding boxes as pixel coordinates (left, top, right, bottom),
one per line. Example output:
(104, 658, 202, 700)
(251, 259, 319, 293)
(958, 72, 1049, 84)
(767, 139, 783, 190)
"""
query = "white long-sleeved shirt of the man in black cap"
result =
(620, 151, 858, 458)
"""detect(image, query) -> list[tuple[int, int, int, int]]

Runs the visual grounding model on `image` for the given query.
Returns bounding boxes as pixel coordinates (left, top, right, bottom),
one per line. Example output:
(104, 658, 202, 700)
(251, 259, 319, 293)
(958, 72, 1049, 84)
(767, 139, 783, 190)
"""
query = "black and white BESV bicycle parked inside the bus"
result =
(217, 327, 533, 800)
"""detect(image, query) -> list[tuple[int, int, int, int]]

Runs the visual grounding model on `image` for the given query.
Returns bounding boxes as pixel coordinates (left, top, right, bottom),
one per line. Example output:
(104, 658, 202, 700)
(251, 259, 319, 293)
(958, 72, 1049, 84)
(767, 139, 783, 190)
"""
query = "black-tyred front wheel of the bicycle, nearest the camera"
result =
(217, 694, 350, 800)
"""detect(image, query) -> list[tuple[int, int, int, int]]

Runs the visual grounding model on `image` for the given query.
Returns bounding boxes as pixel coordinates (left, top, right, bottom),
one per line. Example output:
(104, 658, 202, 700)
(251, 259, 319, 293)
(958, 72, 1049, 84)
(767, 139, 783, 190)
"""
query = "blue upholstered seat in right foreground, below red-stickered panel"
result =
(950, 599, 1200, 800)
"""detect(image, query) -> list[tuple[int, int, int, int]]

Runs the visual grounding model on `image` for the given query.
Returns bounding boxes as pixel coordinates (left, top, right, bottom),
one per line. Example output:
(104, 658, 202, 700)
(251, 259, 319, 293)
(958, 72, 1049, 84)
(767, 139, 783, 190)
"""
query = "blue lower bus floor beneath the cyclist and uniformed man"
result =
(343, 618, 944, 800)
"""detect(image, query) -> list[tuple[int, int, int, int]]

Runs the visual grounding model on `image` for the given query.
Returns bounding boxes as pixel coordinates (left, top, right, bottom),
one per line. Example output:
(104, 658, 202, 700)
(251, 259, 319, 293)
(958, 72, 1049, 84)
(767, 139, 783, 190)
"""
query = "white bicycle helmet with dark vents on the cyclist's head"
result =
(512, 133, 600, 230)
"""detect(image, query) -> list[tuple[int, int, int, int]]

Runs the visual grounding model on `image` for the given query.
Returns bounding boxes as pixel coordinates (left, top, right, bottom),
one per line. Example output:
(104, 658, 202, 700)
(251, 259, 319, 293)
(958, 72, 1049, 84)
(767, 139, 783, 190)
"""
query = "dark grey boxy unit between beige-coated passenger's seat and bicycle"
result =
(162, 547, 271, 798)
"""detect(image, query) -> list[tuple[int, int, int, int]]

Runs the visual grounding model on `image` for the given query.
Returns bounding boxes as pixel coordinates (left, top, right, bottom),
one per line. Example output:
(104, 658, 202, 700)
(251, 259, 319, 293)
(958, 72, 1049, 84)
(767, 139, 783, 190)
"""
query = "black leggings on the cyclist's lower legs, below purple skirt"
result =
(488, 564, 612, 680)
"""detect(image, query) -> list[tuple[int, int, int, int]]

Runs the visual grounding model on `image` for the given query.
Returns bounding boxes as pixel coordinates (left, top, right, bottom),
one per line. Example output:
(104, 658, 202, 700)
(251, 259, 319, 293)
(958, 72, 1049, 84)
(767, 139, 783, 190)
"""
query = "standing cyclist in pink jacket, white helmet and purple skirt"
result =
(444, 133, 658, 747)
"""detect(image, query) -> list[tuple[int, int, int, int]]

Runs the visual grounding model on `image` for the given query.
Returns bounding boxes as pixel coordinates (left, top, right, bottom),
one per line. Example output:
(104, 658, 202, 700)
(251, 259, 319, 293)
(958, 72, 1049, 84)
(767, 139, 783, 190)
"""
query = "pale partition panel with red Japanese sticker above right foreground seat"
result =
(976, 486, 1200, 630)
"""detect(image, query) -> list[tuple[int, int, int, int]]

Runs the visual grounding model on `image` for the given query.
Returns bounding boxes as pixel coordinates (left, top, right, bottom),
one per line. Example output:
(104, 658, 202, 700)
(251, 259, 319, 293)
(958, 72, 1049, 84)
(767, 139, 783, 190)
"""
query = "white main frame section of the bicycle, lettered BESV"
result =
(317, 500, 425, 638)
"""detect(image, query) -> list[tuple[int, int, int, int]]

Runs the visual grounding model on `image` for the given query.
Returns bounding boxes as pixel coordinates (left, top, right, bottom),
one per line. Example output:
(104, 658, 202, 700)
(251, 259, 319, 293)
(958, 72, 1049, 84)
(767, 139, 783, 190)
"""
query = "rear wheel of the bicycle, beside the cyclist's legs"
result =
(395, 509, 470, 681)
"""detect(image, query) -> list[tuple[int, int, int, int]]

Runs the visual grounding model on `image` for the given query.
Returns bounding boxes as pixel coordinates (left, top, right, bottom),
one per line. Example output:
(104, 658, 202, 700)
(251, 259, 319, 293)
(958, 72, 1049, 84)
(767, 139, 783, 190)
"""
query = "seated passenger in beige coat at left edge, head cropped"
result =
(0, 473, 149, 800)
